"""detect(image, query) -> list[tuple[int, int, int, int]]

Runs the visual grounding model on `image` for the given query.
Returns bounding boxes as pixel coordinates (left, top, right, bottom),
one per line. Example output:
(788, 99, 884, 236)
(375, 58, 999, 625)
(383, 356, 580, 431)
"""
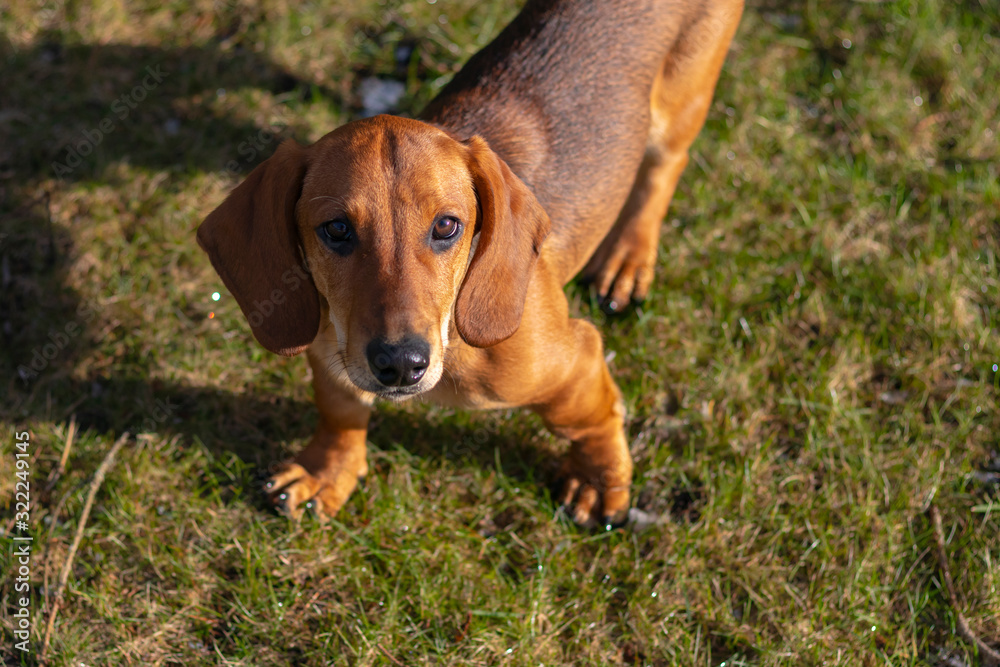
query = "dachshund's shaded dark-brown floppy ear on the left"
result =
(198, 140, 320, 356)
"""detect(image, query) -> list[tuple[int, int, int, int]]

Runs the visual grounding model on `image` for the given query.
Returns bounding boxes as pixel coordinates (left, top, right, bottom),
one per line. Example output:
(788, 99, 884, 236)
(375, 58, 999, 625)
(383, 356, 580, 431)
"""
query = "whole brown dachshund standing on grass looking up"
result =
(198, 0, 743, 524)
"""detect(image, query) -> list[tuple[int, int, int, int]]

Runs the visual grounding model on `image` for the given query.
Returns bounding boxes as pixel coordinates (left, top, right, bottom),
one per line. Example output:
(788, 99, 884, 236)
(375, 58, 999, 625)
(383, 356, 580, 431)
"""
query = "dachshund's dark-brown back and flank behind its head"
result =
(421, 0, 704, 279)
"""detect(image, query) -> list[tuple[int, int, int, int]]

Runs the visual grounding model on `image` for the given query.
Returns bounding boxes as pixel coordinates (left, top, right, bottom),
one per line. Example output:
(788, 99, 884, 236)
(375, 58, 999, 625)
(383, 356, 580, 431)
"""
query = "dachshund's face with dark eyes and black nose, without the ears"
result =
(296, 122, 477, 397)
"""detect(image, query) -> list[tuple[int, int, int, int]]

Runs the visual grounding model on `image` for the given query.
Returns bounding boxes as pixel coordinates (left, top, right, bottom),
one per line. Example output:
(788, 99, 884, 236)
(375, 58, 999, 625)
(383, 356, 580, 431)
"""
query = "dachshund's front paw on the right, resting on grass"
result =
(559, 457, 632, 529)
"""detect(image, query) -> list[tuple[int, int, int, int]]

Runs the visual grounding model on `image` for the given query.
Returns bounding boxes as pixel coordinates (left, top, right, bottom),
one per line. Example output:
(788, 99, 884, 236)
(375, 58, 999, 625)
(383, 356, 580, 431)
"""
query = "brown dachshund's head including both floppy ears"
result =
(198, 116, 550, 398)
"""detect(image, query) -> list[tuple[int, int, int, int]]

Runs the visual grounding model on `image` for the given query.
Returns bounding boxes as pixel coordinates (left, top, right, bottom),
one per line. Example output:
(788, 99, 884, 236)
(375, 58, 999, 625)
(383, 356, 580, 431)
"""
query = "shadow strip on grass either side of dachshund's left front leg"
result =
(9, 375, 556, 507)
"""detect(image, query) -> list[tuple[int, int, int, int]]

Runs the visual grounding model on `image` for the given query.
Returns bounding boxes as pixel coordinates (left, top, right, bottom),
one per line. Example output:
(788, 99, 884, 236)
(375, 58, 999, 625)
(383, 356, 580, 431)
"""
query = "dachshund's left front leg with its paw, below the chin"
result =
(266, 349, 371, 518)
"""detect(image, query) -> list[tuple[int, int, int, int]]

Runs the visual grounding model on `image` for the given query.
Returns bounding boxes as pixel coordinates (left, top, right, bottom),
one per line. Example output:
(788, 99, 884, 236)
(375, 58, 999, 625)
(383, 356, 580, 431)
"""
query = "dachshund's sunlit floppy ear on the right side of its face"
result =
(455, 136, 551, 347)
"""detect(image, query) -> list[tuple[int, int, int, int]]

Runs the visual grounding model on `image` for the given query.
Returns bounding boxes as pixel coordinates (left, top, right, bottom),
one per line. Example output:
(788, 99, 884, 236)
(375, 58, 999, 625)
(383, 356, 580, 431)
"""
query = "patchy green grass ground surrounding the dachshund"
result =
(0, 0, 1000, 667)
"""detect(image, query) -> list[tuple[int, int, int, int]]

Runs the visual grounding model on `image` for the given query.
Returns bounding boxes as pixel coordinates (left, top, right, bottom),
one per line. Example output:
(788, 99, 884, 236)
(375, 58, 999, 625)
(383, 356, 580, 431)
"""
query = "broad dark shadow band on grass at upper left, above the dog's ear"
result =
(0, 34, 345, 183)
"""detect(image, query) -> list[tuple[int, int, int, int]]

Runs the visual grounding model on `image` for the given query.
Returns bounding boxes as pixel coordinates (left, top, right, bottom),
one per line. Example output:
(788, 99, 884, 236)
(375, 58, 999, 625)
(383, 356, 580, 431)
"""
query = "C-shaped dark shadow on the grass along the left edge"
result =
(0, 33, 324, 464)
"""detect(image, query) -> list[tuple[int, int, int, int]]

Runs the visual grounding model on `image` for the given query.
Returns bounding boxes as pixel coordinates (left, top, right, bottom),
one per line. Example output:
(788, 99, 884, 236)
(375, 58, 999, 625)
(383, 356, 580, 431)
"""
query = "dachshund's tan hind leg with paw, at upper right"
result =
(583, 0, 743, 311)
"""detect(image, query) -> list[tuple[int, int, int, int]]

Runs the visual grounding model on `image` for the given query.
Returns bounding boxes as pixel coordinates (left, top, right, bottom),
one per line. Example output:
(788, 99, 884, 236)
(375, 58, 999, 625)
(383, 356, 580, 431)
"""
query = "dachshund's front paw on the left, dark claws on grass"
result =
(264, 463, 362, 522)
